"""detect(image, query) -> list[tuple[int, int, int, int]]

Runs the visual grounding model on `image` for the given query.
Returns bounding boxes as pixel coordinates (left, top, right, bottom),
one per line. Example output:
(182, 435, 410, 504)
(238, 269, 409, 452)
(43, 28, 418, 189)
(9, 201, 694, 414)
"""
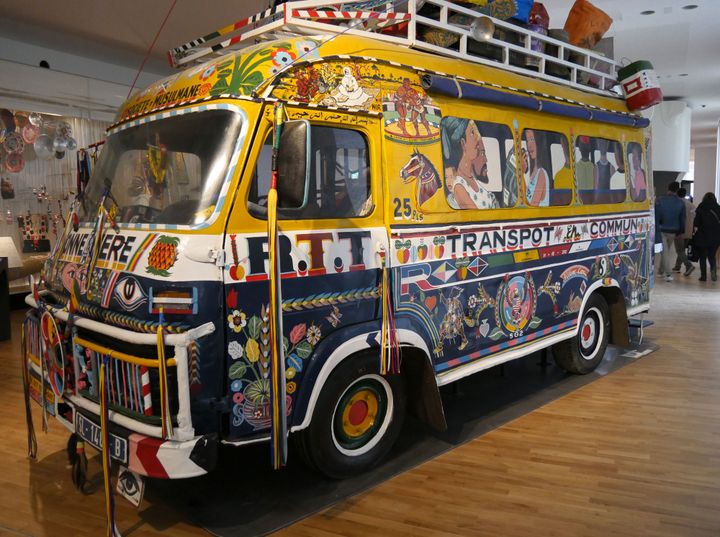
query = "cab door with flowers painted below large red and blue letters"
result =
(225, 111, 387, 439)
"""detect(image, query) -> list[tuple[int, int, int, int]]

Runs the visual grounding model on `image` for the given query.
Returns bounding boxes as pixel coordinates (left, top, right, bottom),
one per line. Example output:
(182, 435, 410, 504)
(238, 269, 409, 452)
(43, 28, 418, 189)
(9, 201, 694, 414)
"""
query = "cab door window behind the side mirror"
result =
(248, 125, 373, 219)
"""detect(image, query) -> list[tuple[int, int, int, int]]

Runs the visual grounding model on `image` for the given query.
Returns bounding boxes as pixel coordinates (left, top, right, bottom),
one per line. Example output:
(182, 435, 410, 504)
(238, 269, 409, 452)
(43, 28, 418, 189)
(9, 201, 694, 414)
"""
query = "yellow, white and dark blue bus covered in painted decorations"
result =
(23, 0, 653, 486)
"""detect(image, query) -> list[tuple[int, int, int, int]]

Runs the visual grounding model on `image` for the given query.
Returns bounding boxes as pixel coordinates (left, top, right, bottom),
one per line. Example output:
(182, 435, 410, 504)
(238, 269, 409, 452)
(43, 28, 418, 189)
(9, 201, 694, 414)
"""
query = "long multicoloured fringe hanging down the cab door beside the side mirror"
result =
(268, 103, 287, 470)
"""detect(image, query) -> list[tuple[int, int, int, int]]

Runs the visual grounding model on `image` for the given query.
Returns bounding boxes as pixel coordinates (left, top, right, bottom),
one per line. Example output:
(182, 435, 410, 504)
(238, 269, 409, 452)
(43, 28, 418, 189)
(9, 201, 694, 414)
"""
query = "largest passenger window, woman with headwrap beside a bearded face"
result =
(440, 117, 518, 209)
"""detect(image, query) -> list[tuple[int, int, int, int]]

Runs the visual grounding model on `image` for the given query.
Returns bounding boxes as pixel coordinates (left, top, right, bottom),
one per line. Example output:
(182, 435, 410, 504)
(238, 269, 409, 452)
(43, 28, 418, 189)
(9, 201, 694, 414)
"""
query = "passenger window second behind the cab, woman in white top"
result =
(521, 129, 572, 207)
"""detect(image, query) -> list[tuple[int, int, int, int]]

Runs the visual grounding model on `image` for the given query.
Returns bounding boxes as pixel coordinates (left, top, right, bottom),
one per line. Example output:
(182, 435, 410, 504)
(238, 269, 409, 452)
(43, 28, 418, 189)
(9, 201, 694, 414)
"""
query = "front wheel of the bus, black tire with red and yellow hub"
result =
(298, 353, 406, 479)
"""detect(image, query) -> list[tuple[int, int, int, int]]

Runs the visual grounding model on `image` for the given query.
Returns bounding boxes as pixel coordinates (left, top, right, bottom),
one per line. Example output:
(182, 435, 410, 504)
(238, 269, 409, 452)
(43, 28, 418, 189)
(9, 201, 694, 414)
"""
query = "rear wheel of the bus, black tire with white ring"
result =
(552, 293, 610, 375)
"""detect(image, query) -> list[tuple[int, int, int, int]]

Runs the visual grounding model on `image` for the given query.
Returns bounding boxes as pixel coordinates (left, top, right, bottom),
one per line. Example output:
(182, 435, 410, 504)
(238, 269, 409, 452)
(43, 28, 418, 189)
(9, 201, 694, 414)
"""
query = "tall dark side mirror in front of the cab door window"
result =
(277, 120, 310, 209)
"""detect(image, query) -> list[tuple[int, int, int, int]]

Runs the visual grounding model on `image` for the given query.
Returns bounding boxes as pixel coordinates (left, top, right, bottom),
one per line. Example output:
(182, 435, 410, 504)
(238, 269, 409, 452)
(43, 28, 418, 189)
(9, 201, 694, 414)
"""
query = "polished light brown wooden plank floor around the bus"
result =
(0, 271, 720, 537)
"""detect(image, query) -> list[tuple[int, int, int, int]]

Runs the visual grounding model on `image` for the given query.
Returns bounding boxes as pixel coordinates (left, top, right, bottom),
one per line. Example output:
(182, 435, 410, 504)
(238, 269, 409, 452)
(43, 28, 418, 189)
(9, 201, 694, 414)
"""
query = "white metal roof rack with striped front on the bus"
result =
(168, 0, 621, 97)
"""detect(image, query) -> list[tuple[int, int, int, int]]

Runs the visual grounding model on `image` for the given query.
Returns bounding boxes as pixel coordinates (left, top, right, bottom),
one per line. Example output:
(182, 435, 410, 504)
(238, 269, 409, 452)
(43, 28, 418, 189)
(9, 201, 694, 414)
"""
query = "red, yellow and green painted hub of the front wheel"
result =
(333, 379, 387, 449)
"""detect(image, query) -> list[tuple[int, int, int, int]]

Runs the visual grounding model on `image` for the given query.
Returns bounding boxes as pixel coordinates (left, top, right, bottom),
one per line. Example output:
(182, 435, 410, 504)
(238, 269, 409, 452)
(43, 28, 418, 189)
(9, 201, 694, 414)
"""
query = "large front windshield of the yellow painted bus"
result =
(79, 110, 242, 225)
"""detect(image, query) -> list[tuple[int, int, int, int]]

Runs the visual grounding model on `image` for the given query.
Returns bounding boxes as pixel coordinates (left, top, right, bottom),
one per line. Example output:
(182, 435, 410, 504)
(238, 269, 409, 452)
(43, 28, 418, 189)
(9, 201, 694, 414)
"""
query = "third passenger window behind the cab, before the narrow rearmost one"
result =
(575, 136, 627, 205)
